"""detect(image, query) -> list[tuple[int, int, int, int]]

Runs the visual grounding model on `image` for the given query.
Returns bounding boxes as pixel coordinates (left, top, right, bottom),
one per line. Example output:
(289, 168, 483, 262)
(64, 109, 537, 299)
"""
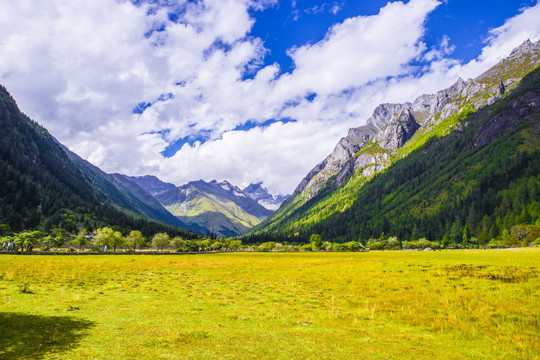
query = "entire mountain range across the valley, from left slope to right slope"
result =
(0, 41, 540, 245)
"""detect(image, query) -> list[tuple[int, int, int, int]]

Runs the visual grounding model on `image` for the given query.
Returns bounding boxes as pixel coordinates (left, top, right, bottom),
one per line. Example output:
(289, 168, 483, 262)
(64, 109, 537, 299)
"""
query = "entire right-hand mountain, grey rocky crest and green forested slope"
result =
(248, 41, 540, 248)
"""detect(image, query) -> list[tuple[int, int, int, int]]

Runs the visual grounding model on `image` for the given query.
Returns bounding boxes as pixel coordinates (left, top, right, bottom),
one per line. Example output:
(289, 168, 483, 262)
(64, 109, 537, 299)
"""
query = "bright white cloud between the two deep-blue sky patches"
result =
(277, 0, 438, 97)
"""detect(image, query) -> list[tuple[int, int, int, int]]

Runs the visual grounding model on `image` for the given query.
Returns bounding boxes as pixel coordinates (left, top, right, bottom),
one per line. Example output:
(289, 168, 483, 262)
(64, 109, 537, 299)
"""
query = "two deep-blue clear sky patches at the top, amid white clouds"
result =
(249, 0, 536, 71)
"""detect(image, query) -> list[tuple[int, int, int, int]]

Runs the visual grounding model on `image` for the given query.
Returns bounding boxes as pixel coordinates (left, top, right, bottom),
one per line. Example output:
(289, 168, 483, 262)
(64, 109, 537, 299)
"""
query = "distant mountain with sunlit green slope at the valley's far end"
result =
(155, 180, 272, 237)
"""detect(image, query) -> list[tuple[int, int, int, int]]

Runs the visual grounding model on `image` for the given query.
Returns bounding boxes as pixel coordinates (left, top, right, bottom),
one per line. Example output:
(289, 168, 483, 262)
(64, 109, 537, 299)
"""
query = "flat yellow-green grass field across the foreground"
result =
(0, 249, 540, 360)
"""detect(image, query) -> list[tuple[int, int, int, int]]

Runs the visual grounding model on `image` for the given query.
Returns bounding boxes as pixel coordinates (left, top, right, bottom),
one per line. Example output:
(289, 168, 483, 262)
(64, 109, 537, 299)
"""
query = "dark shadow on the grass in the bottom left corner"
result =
(0, 312, 95, 360)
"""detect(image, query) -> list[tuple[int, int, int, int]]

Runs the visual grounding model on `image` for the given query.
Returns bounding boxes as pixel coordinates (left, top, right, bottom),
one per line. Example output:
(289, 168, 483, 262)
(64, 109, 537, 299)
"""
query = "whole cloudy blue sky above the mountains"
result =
(0, 0, 540, 194)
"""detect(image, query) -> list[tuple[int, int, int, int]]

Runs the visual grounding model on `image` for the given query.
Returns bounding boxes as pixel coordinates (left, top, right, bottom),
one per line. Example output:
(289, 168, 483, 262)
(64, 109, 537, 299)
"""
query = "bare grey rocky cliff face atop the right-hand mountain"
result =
(287, 40, 540, 203)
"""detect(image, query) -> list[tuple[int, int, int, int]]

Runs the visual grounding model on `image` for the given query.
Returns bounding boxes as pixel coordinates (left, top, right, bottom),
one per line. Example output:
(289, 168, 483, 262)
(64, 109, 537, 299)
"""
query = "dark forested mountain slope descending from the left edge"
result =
(0, 87, 191, 236)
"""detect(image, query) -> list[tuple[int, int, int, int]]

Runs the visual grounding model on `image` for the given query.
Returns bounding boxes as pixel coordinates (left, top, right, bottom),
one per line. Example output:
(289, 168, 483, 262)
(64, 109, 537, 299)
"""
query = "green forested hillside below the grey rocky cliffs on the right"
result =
(246, 65, 540, 246)
